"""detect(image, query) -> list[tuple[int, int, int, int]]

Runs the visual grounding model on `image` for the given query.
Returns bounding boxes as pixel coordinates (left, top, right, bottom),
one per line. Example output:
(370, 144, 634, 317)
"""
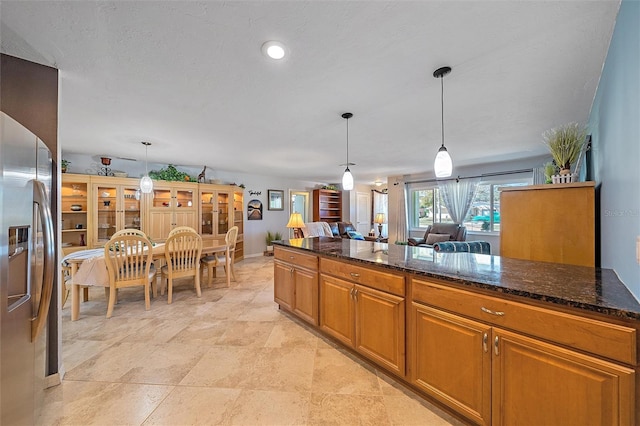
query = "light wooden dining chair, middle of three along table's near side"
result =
(161, 228, 202, 303)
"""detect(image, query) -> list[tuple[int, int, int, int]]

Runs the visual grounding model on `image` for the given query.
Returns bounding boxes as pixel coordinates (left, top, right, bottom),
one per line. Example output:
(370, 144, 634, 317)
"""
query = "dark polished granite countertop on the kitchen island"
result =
(274, 237, 640, 320)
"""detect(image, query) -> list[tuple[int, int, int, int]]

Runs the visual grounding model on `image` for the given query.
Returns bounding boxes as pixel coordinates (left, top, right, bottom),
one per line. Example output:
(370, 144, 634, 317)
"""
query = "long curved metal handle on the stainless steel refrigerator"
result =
(31, 180, 55, 341)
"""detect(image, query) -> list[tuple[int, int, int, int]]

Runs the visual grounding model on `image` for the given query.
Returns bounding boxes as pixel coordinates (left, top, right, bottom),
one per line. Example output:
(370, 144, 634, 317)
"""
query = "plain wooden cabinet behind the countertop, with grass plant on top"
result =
(500, 182, 596, 266)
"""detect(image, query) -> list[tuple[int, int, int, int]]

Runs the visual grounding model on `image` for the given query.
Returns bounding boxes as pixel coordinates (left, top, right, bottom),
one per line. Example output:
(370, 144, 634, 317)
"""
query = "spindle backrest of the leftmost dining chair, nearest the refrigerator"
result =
(104, 235, 153, 287)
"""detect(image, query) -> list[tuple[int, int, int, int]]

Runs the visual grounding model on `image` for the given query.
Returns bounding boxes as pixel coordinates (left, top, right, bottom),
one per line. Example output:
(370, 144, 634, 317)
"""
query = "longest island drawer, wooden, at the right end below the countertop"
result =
(412, 279, 637, 365)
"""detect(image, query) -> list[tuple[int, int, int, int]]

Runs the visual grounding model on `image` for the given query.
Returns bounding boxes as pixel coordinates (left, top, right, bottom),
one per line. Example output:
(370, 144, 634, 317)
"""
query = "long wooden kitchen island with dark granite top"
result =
(274, 237, 640, 425)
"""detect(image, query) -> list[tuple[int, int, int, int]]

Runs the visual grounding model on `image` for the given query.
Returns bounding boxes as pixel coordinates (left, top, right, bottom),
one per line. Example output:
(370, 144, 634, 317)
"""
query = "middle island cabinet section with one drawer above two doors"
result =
(320, 258, 405, 376)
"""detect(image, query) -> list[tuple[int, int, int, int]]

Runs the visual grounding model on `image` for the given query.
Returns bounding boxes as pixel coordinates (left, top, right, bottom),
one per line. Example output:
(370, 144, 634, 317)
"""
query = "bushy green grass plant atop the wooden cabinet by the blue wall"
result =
(543, 123, 587, 176)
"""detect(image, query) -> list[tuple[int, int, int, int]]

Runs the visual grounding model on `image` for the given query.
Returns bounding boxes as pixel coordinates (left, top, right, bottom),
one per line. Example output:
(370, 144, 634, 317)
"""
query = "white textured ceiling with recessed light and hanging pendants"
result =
(0, 0, 619, 183)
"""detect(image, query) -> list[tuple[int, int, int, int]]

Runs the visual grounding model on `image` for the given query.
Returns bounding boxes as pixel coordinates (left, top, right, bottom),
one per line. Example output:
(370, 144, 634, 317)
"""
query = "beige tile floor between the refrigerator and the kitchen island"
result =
(40, 257, 461, 425)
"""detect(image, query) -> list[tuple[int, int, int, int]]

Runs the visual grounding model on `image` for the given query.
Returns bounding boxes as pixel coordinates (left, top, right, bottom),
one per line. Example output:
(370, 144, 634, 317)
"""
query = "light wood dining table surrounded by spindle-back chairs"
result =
(61, 243, 231, 321)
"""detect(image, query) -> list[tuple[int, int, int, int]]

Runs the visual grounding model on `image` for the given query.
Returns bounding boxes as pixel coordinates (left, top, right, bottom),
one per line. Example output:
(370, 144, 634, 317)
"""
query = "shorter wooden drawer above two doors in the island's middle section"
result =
(320, 258, 405, 296)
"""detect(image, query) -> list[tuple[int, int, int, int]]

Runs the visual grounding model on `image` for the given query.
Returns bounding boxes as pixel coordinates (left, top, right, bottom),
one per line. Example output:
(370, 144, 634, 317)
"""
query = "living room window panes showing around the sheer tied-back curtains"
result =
(408, 178, 531, 232)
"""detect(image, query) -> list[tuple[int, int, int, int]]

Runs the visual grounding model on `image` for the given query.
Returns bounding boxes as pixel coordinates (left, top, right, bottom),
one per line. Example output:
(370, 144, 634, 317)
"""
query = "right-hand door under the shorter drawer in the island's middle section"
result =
(354, 285, 405, 376)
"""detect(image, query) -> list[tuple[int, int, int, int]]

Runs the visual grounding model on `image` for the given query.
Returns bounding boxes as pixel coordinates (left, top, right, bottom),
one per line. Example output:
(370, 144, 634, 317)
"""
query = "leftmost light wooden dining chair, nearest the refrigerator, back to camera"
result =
(104, 235, 156, 318)
